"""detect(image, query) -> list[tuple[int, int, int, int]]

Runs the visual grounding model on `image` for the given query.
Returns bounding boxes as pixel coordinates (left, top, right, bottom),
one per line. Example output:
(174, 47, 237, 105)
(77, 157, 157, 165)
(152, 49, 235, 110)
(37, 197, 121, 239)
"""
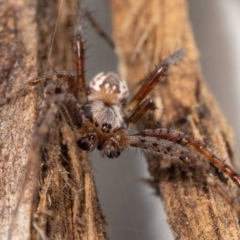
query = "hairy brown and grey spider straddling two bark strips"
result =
(0, 1, 240, 238)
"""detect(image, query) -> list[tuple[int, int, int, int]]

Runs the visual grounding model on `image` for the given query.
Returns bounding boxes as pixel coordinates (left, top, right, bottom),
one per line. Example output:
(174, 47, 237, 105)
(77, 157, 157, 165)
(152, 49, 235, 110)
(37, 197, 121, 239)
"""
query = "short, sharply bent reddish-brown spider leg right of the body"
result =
(128, 99, 156, 129)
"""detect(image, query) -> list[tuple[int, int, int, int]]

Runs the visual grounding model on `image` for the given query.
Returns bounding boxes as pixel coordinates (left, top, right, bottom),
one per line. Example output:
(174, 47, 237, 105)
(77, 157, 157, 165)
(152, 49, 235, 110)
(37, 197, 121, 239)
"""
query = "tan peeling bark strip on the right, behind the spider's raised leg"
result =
(110, 0, 240, 240)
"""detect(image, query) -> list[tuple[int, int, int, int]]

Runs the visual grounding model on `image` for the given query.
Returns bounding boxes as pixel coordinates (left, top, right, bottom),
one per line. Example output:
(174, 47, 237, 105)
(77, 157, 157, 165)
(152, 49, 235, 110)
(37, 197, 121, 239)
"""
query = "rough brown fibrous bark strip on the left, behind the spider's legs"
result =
(0, 0, 106, 240)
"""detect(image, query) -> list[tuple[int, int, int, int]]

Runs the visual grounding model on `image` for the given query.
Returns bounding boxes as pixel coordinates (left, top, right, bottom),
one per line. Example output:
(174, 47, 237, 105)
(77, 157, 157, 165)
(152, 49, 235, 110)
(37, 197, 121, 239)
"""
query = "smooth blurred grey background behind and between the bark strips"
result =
(81, 0, 240, 240)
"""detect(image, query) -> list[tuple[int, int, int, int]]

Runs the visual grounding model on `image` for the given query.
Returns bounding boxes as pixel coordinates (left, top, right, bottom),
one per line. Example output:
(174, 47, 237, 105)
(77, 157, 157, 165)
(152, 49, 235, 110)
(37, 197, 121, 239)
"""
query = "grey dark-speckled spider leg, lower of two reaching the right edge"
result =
(127, 134, 240, 216)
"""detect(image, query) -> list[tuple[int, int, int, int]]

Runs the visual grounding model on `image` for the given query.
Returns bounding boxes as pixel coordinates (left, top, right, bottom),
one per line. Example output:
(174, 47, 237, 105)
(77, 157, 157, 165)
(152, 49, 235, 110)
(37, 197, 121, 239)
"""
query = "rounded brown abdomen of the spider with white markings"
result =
(88, 72, 129, 105)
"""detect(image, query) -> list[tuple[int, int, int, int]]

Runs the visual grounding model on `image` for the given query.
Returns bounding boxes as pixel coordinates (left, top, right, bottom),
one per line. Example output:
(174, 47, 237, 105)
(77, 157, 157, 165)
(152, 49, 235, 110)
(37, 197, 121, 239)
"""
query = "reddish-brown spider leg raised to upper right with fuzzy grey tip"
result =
(124, 49, 186, 116)
